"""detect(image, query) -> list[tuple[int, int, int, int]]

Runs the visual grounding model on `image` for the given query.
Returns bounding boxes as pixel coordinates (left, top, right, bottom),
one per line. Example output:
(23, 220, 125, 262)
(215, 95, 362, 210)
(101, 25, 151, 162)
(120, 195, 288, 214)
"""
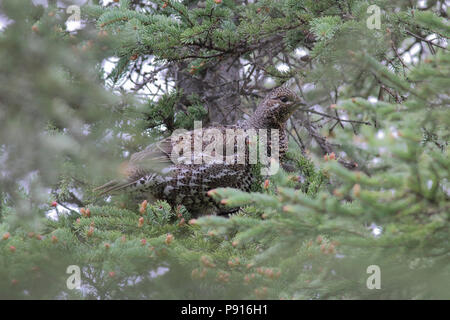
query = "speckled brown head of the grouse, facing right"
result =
(250, 87, 304, 128)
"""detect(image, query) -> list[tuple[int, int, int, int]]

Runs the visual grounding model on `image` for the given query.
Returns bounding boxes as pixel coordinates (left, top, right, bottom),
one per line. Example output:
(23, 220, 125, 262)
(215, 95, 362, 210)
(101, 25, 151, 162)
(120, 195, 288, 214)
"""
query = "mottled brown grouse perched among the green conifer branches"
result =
(94, 86, 303, 217)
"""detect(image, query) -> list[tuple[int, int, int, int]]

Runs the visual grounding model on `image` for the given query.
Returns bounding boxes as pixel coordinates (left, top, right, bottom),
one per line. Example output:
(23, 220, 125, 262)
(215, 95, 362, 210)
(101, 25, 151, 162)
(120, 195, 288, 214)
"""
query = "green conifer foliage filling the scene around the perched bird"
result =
(0, 0, 450, 299)
